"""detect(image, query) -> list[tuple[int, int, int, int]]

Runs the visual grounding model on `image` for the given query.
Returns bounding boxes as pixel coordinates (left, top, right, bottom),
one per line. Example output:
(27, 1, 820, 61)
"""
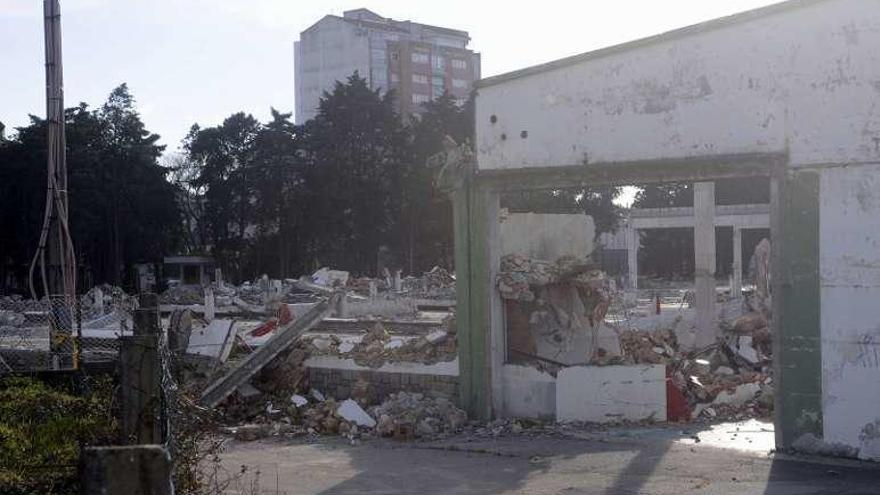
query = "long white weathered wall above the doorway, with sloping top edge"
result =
(476, 0, 880, 169)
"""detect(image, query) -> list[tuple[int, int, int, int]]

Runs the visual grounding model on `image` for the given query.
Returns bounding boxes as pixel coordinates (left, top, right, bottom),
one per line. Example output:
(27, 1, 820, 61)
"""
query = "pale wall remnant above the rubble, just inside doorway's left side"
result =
(501, 213, 596, 262)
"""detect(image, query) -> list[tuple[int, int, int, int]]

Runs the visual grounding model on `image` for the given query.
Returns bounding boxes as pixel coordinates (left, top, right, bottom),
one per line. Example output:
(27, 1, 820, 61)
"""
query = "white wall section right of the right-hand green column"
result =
(819, 164, 880, 460)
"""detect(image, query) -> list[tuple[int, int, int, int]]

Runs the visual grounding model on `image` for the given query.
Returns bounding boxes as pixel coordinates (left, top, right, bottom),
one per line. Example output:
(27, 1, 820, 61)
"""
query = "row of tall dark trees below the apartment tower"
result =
(0, 73, 473, 293)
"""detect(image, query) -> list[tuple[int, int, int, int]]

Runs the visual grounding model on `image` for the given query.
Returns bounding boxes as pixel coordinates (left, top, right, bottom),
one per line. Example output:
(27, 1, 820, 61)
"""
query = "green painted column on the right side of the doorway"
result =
(771, 171, 822, 448)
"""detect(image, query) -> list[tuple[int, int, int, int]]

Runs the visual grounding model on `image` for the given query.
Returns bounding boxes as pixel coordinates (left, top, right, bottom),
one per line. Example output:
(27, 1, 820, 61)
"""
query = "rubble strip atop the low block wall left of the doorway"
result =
(305, 319, 457, 368)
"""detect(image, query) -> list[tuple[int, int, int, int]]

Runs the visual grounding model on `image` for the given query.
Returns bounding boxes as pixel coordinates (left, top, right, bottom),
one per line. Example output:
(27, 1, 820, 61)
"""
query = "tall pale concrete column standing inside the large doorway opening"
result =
(694, 182, 718, 347)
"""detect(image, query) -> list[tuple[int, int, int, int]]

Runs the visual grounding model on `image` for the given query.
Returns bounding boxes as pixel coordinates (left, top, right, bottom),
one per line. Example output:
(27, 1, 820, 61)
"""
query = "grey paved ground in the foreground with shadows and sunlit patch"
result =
(224, 422, 880, 495)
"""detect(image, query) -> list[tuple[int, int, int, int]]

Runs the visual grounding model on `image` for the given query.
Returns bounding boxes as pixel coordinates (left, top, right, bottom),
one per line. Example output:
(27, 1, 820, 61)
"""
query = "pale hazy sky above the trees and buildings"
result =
(0, 0, 775, 150)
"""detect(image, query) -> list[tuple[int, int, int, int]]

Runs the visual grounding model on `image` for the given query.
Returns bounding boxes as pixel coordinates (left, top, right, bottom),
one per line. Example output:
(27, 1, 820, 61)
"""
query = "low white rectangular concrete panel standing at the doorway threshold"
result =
(556, 365, 666, 423)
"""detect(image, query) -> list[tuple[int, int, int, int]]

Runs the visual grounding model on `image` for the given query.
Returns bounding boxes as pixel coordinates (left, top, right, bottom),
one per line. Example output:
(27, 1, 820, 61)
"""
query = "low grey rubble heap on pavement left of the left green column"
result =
(370, 392, 467, 438)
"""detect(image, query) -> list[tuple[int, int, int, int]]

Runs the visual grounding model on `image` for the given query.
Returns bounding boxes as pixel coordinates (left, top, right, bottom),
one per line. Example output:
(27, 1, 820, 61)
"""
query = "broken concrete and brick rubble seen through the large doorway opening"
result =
(496, 254, 773, 421)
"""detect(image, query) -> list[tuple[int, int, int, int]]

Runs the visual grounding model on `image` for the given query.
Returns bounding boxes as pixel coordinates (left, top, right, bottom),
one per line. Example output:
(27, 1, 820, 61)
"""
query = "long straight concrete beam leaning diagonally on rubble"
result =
(199, 297, 335, 407)
